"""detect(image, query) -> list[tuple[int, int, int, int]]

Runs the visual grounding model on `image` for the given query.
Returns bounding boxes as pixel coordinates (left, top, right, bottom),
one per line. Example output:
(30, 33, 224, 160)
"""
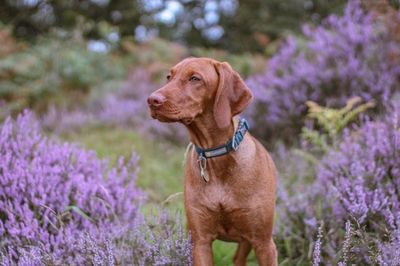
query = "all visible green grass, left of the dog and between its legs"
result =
(61, 127, 257, 266)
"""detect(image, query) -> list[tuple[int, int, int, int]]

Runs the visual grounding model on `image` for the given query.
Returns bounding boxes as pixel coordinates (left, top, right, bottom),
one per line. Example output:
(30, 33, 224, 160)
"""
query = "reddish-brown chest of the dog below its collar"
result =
(185, 149, 265, 241)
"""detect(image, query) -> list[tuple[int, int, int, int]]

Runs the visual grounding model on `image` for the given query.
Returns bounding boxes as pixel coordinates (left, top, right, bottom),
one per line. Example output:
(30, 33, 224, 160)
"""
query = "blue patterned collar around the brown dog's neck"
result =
(194, 118, 249, 160)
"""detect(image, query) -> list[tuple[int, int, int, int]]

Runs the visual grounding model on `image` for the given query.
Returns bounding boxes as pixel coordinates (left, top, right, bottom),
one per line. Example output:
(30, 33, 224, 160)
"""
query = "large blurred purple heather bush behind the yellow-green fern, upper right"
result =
(247, 0, 400, 141)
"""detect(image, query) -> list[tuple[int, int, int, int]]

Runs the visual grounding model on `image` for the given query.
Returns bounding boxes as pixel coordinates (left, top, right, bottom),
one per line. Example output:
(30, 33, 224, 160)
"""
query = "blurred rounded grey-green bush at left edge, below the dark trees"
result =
(0, 30, 126, 112)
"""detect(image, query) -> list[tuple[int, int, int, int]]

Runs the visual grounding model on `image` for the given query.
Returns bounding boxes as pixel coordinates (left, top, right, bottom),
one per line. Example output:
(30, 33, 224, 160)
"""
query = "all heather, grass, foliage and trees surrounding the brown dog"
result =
(0, 0, 400, 265)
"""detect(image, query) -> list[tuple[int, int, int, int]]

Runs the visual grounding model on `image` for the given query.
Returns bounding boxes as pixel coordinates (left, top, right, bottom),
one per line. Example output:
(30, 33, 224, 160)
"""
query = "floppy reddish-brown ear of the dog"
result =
(214, 62, 253, 128)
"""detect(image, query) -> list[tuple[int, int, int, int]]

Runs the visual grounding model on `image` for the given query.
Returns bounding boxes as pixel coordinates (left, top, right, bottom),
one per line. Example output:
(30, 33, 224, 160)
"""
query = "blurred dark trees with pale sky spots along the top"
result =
(0, 0, 398, 52)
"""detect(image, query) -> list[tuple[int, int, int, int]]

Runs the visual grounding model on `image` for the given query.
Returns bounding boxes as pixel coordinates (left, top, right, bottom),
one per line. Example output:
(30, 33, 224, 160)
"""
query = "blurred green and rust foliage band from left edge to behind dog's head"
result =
(0, 23, 265, 120)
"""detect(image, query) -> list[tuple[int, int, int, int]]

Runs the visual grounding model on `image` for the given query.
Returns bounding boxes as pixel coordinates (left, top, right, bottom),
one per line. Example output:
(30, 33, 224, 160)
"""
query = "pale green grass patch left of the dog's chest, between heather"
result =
(63, 127, 184, 204)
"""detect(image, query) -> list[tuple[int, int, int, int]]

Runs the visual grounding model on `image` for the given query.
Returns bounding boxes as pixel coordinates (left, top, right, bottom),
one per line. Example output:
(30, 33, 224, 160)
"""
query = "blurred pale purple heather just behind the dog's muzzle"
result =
(43, 69, 187, 141)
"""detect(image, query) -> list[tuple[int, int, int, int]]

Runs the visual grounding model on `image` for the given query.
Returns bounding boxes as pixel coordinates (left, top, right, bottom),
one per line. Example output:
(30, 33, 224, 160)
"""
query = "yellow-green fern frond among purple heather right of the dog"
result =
(301, 97, 375, 152)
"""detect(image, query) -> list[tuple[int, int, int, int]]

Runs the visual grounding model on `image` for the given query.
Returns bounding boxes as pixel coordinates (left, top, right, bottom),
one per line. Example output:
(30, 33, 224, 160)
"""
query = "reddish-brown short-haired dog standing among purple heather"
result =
(148, 58, 277, 265)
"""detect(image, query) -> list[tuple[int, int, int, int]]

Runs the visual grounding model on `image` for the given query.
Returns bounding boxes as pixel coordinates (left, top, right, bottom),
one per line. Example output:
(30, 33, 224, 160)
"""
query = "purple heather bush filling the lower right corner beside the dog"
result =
(274, 102, 400, 265)
